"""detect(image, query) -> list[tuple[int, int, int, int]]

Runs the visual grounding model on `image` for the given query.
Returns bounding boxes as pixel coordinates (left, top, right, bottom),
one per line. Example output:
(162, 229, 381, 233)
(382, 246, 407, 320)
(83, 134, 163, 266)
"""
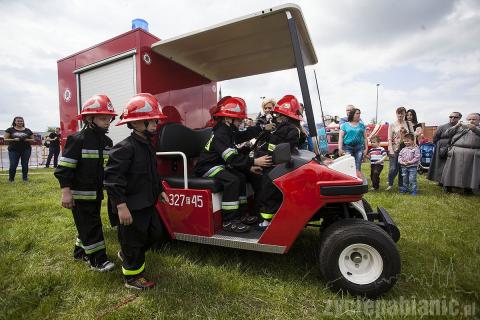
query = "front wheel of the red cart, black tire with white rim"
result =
(319, 219, 401, 298)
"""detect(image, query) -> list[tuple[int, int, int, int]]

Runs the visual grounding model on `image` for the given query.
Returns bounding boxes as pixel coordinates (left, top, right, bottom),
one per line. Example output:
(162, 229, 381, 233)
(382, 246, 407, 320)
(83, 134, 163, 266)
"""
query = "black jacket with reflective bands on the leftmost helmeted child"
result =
(54, 128, 112, 201)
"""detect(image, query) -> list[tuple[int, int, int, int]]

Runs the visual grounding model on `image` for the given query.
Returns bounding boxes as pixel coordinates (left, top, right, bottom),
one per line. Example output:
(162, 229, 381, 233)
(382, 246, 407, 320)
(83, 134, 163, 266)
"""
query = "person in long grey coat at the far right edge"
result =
(441, 113, 480, 194)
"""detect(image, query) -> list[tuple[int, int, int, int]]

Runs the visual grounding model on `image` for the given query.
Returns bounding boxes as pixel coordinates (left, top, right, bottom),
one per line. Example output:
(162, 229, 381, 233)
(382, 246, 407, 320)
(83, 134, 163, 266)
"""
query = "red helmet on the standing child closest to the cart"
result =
(116, 93, 167, 126)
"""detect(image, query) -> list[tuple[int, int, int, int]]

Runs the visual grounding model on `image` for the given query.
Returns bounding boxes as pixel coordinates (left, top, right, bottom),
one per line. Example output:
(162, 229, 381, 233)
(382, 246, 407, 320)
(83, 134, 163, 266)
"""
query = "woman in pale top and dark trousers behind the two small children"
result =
(386, 107, 413, 191)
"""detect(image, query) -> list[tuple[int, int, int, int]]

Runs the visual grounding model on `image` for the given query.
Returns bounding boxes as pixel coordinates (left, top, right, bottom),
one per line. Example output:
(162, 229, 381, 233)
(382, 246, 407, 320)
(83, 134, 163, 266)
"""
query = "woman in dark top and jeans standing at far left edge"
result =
(5, 117, 34, 182)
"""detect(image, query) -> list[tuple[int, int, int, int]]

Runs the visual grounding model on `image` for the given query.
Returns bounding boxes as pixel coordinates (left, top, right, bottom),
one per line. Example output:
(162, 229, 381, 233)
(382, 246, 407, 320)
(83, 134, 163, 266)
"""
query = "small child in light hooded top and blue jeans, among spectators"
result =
(398, 133, 420, 196)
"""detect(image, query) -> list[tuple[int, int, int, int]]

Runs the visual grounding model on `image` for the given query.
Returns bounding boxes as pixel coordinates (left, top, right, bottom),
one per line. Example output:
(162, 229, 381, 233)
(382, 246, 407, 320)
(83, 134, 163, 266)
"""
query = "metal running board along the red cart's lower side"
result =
(174, 231, 286, 254)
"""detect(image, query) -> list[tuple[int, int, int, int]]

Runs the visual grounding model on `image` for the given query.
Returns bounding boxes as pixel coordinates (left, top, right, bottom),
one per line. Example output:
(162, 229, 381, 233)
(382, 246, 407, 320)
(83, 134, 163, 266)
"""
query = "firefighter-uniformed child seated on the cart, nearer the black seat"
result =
(195, 96, 271, 233)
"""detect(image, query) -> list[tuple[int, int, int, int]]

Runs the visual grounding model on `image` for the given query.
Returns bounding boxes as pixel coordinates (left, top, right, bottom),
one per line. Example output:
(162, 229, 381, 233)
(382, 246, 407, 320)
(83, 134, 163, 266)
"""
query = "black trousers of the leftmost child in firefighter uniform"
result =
(72, 200, 107, 266)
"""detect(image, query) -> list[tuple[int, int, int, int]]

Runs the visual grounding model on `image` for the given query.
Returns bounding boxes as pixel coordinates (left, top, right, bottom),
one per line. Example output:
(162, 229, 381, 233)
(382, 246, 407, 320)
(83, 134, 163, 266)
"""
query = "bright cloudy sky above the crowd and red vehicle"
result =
(0, 0, 480, 131)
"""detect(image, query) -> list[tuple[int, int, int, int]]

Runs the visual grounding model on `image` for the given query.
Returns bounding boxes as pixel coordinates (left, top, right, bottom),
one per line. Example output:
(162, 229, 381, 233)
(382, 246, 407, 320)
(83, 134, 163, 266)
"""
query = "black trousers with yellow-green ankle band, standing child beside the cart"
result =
(118, 206, 162, 279)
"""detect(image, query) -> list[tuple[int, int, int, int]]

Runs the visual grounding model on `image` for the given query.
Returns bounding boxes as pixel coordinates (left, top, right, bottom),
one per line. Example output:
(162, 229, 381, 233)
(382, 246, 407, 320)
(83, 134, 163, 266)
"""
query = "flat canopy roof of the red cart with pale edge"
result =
(152, 4, 318, 81)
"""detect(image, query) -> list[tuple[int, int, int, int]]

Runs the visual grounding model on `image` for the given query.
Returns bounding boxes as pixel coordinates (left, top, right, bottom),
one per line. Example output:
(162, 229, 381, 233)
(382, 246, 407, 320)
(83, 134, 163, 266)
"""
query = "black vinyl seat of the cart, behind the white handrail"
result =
(157, 123, 223, 193)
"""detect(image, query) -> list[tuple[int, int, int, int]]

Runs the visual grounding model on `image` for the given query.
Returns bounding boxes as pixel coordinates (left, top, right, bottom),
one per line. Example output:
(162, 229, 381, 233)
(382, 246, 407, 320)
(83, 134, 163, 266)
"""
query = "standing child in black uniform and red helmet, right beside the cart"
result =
(104, 93, 167, 290)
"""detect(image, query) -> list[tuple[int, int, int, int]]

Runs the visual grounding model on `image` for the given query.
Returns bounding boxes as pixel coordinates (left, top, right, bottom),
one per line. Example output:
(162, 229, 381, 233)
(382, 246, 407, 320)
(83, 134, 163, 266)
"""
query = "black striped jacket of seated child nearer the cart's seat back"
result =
(195, 122, 261, 177)
